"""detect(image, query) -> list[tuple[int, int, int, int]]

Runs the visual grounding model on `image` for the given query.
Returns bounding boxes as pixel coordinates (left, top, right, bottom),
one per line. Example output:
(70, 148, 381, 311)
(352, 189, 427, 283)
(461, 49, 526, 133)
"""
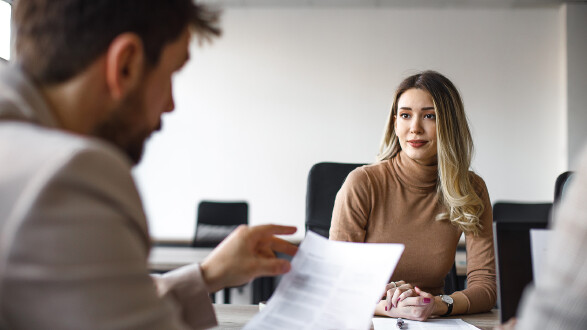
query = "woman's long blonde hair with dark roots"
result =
(377, 71, 485, 235)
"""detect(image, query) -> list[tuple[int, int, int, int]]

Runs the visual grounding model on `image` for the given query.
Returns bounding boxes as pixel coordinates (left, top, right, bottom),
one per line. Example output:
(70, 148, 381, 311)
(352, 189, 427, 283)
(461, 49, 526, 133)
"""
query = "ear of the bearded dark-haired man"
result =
(106, 33, 145, 99)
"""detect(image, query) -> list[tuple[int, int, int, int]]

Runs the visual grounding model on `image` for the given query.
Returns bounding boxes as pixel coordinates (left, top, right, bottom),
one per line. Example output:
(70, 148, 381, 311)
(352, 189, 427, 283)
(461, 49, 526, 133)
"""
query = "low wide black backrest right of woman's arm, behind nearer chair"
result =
(493, 202, 552, 223)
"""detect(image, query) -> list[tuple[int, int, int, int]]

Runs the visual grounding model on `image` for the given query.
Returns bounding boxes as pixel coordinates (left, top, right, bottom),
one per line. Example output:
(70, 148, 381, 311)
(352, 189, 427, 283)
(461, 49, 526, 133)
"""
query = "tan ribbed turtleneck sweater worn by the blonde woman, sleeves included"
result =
(330, 152, 496, 314)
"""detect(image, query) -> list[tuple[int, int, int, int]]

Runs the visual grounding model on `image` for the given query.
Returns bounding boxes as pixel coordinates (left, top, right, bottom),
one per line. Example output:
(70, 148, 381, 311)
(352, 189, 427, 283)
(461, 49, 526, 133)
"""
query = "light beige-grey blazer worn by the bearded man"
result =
(0, 64, 216, 329)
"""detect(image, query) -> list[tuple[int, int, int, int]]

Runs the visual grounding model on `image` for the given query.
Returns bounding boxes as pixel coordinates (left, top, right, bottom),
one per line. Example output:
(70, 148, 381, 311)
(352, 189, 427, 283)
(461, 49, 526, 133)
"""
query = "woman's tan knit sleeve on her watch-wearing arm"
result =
(461, 175, 497, 313)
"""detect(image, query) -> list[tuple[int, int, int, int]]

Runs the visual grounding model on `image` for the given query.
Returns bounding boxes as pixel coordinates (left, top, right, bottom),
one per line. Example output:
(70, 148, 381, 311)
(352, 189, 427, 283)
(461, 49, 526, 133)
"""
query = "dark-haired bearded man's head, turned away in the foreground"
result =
(14, 0, 220, 163)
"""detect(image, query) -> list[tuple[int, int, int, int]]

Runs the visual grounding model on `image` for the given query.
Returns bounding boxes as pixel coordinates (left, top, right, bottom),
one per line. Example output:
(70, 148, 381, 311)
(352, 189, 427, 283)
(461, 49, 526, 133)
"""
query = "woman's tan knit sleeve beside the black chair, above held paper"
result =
(330, 168, 371, 242)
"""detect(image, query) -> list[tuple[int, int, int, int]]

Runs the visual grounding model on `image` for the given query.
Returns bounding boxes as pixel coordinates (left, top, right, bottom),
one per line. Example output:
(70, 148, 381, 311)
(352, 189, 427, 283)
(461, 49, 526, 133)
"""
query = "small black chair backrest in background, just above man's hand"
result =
(192, 201, 249, 247)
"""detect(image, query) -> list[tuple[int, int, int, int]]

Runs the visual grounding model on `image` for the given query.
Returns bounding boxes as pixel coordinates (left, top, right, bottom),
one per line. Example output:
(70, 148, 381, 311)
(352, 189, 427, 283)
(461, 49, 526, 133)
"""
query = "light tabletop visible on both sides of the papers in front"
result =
(214, 304, 499, 330)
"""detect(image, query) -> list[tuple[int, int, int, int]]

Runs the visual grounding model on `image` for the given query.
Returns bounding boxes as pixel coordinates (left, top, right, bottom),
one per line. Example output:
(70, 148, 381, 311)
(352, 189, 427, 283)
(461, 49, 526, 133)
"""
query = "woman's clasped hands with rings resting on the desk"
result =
(375, 281, 434, 321)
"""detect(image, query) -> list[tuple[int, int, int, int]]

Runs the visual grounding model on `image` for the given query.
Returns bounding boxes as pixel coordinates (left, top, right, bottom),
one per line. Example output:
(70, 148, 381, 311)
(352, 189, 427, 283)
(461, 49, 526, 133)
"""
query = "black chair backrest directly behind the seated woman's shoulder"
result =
(306, 162, 365, 238)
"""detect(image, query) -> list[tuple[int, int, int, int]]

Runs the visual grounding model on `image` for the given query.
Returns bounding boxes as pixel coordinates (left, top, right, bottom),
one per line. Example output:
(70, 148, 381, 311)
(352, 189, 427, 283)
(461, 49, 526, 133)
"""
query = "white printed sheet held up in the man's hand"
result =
(244, 232, 404, 330)
